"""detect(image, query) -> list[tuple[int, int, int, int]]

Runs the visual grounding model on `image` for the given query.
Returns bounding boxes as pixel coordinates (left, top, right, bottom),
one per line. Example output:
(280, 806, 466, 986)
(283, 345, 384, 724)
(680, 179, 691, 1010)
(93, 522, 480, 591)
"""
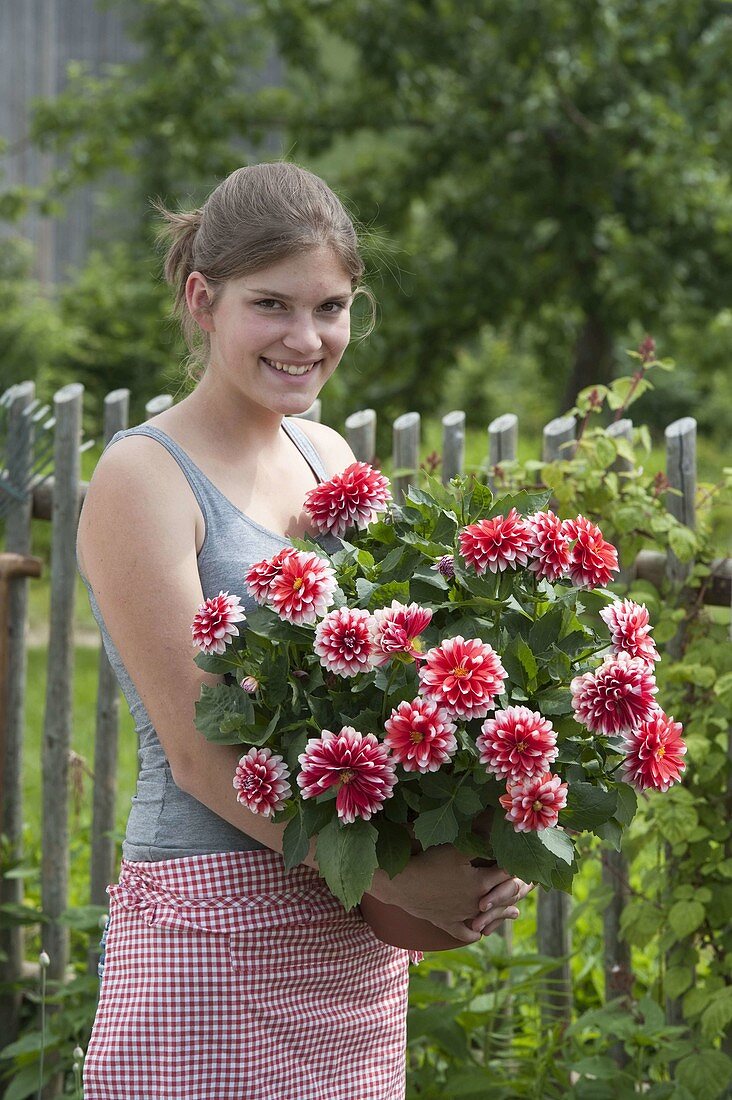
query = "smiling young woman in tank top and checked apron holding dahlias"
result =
(78, 163, 527, 1100)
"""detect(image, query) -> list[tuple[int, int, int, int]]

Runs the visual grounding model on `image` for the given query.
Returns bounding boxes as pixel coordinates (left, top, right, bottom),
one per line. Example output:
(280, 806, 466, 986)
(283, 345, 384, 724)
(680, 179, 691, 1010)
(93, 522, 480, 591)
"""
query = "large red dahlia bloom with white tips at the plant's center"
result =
(419, 635, 507, 718)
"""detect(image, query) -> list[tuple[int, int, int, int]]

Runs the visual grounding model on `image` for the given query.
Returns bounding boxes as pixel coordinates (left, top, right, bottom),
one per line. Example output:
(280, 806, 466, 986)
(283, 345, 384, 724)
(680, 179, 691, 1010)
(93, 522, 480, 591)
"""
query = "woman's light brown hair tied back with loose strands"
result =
(153, 161, 375, 381)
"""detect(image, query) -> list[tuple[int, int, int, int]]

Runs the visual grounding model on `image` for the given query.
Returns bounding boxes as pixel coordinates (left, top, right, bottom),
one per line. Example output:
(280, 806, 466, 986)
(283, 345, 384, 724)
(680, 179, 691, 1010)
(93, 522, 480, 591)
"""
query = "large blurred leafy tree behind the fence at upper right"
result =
(266, 0, 732, 407)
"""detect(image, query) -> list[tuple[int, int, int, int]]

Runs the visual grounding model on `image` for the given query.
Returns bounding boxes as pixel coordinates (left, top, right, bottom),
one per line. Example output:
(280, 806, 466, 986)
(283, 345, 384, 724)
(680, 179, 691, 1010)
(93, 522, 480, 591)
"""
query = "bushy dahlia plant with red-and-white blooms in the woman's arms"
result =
(193, 462, 686, 948)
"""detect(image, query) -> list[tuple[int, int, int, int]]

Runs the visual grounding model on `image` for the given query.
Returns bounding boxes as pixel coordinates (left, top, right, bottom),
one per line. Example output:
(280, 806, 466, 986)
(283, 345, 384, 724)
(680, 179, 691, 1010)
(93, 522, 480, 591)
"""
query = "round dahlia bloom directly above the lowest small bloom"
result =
(476, 706, 559, 782)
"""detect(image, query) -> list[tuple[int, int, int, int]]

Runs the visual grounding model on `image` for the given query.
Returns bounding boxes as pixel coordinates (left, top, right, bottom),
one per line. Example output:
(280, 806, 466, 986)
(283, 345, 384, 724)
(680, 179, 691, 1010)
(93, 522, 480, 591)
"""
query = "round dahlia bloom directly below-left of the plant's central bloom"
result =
(384, 699, 458, 771)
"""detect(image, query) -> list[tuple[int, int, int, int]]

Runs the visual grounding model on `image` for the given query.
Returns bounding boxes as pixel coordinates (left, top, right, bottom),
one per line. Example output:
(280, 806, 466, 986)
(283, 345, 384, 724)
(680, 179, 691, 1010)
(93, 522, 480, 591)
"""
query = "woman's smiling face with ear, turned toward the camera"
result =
(186, 246, 353, 416)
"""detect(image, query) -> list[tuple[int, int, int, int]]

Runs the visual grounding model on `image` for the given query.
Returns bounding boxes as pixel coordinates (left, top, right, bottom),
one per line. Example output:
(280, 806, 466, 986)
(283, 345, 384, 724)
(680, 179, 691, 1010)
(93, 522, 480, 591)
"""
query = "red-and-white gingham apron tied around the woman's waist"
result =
(84, 850, 409, 1100)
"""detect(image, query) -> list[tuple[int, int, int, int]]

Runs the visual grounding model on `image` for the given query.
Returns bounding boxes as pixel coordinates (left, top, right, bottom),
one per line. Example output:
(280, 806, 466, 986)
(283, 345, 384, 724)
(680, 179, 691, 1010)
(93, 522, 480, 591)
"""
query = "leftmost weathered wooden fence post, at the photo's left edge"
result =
(0, 382, 37, 1045)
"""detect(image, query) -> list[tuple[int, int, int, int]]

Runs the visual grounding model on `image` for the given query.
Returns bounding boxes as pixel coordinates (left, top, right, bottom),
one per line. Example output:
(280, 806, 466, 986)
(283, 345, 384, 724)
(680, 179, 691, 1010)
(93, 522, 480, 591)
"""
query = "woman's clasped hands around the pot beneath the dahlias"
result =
(370, 844, 519, 944)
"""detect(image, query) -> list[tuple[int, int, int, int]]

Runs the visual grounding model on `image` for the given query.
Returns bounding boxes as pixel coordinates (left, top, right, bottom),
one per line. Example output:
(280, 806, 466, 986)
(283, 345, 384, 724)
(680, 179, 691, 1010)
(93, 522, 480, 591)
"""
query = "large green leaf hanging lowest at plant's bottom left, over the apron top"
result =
(316, 817, 379, 910)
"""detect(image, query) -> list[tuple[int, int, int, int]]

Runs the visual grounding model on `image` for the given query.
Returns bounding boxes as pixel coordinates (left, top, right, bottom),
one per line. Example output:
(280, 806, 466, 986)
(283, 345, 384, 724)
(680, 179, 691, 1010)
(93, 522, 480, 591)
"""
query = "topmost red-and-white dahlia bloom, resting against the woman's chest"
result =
(305, 462, 392, 536)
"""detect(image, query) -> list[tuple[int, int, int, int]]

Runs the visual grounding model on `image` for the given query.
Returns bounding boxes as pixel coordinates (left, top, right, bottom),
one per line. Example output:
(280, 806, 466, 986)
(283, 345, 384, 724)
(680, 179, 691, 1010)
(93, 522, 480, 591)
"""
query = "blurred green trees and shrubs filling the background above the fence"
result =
(0, 0, 732, 453)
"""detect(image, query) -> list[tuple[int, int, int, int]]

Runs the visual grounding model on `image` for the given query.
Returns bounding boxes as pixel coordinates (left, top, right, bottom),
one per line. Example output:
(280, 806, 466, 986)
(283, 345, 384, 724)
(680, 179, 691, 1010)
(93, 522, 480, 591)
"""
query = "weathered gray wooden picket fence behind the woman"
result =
(0, 382, 732, 1045)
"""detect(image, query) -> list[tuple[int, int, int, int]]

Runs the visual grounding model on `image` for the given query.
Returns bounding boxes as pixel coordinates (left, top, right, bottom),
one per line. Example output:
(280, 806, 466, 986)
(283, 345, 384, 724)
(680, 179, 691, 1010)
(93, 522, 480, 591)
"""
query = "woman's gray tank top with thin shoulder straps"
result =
(77, 418, 340, 860)
